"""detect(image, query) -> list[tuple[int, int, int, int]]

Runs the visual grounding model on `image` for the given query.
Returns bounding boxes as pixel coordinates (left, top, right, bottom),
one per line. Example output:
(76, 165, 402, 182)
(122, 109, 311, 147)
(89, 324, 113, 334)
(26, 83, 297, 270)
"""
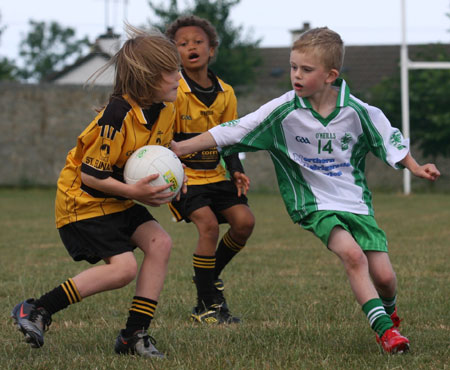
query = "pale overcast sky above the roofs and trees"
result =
(0, 0, 450, 59)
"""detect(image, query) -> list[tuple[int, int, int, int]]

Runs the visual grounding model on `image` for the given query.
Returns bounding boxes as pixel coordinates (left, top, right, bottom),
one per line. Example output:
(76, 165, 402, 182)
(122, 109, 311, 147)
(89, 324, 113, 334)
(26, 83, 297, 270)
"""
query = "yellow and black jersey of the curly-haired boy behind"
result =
(174, 71, 237, 185)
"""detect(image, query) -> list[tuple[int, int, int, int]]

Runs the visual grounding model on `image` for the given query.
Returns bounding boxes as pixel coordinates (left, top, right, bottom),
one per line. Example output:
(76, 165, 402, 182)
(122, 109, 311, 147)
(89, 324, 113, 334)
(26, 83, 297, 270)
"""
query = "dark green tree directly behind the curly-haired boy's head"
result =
(148, 0, 262, 86)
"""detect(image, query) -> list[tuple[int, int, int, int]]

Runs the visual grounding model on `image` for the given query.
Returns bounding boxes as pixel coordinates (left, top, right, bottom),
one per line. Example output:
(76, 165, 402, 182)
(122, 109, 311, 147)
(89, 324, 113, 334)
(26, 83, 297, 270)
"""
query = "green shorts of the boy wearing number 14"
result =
(300, 211, 388, 252)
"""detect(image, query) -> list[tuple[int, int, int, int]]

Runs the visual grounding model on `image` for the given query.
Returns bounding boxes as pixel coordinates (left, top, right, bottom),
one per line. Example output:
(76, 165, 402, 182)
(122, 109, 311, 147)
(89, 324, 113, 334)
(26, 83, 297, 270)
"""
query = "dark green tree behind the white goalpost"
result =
(370, 44, 450, 158)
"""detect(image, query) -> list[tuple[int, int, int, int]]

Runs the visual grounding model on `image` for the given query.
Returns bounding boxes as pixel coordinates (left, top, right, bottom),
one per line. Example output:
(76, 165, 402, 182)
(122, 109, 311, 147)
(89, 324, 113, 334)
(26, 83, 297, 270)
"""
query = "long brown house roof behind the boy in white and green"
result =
(255, 44, 450, 92)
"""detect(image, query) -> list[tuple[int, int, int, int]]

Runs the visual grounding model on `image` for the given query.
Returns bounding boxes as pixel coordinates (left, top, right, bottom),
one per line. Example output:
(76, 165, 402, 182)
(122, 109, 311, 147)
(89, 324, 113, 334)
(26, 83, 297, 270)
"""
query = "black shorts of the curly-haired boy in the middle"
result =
(170, 181, 248, 224)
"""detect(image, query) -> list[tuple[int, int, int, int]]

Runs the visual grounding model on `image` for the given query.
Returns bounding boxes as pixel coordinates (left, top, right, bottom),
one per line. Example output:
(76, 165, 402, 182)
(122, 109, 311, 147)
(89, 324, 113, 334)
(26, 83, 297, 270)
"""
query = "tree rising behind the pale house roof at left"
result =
(18, 20, 90, 81)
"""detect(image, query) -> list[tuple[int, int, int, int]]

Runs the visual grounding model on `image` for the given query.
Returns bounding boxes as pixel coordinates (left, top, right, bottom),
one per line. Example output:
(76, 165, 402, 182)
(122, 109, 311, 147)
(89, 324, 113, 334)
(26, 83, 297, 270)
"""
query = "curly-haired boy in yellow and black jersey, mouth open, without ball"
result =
(166, 16, 255, 324)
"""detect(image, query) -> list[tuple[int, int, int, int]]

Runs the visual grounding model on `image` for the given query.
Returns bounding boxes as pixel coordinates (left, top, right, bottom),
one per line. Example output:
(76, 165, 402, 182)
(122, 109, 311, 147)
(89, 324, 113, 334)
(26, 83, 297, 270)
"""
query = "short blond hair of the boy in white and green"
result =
(291, 27, 345, 72)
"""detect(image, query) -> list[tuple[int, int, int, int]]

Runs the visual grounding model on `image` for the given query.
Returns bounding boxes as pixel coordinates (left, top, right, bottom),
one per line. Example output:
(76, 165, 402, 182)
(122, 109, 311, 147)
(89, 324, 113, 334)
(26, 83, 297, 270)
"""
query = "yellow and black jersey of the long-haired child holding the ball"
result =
(55, 96, 175, 228)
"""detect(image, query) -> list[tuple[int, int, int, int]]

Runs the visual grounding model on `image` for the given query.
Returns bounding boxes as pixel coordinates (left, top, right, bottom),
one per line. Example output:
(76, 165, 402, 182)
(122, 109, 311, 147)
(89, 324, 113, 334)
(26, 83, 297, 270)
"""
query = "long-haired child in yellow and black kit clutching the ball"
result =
(11, 26, 180, 358)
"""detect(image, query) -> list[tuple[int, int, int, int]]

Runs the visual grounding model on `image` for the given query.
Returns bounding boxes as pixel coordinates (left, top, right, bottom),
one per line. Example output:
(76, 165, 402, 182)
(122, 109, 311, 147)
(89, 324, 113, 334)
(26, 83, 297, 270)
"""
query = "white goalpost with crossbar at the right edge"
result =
(400, 0, 450, 195)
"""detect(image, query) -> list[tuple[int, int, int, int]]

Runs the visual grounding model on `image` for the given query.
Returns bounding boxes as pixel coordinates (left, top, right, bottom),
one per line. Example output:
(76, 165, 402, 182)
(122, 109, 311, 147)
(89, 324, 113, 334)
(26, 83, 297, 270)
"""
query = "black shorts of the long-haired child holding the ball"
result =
(58, 204, 156, 264)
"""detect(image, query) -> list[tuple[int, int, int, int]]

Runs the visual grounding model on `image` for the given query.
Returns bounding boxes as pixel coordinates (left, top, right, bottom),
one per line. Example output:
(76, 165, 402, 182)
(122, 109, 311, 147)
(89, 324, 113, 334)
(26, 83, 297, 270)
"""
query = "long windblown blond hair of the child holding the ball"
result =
(88, 24, 181, 108)
